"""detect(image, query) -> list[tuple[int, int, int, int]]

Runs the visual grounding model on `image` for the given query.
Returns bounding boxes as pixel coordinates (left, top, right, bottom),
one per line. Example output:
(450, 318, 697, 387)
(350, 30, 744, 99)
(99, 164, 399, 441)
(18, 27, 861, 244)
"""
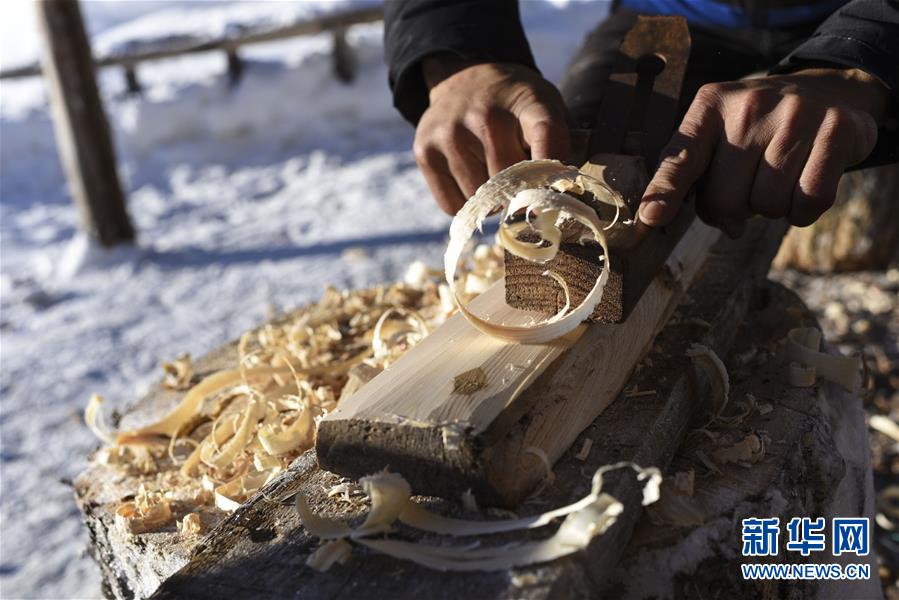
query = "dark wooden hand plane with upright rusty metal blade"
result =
(505, 16, 696, 323)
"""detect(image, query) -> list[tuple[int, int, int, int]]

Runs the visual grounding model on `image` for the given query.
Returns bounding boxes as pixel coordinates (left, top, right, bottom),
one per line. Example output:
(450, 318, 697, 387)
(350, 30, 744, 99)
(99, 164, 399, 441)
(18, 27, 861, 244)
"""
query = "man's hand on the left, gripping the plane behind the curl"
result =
(413, 55, 570, 214)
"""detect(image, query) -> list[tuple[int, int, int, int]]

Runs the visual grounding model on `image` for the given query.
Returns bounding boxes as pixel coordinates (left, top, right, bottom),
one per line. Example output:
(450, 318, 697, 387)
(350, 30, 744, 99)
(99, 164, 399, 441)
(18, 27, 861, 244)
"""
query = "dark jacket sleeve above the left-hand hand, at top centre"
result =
(384, 0, 536, 124)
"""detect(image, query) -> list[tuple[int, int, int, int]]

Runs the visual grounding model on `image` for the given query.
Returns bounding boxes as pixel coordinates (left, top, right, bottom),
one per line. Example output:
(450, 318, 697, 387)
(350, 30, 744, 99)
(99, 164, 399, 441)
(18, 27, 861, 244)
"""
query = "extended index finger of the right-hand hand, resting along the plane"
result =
(638, 88, 722, 227)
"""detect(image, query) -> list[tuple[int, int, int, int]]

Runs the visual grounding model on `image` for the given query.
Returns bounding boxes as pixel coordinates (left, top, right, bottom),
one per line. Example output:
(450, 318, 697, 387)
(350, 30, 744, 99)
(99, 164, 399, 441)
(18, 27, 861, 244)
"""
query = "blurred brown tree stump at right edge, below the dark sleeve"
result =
(773, 164, 899, 273)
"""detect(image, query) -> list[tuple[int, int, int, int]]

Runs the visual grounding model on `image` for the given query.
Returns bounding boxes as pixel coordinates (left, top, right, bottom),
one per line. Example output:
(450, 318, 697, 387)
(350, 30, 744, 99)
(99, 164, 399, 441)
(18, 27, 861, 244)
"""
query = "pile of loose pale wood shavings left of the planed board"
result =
(85, 245, 503, 536)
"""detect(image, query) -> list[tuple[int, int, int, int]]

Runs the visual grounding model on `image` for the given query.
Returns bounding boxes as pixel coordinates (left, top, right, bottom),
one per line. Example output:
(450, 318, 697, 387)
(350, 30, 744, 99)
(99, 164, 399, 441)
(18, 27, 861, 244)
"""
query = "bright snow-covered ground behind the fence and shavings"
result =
(0, 0, 607, 598)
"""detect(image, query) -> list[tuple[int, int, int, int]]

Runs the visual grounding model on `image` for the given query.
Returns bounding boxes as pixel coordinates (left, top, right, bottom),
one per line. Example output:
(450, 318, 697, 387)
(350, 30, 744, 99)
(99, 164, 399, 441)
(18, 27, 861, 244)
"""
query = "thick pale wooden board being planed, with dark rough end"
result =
(316, 212, 719, 505)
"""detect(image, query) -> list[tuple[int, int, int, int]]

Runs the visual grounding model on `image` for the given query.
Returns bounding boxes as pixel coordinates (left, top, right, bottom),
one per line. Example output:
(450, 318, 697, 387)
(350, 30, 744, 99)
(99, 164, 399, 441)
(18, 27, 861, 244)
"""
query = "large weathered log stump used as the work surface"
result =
(76, 222, 870, 598)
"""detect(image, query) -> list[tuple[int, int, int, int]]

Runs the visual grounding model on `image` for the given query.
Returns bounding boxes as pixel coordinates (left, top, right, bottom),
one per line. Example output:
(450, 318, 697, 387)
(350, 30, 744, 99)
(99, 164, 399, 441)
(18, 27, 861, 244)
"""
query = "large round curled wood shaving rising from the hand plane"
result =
(444, 160, 623, 344)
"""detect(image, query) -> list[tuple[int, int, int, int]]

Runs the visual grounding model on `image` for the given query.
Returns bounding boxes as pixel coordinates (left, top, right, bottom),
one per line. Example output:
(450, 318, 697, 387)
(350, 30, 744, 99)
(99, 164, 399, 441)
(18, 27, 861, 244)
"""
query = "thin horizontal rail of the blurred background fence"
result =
(0, 7, 384, 79)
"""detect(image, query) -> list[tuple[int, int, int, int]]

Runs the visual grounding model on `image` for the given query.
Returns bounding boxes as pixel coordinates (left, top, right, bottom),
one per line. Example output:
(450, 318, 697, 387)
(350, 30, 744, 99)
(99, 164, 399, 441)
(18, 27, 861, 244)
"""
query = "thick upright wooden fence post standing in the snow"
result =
(34, 0, 134, 246)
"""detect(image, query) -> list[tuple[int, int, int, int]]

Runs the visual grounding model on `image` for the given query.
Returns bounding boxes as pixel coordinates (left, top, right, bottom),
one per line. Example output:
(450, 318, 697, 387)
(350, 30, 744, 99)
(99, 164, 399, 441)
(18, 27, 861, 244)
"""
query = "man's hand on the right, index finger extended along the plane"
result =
(639, 69, 887, 237)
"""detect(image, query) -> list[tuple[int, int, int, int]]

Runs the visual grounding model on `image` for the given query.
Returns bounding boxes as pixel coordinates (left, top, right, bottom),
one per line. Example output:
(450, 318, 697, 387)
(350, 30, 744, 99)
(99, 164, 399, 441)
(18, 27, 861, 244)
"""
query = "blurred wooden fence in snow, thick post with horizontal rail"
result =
(14, 0, 383, 246)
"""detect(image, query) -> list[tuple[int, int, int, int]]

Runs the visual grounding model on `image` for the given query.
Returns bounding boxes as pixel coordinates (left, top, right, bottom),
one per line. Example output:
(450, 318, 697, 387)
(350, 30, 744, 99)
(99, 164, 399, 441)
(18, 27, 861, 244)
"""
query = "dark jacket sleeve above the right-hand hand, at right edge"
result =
(773, 0, 899, 168)
